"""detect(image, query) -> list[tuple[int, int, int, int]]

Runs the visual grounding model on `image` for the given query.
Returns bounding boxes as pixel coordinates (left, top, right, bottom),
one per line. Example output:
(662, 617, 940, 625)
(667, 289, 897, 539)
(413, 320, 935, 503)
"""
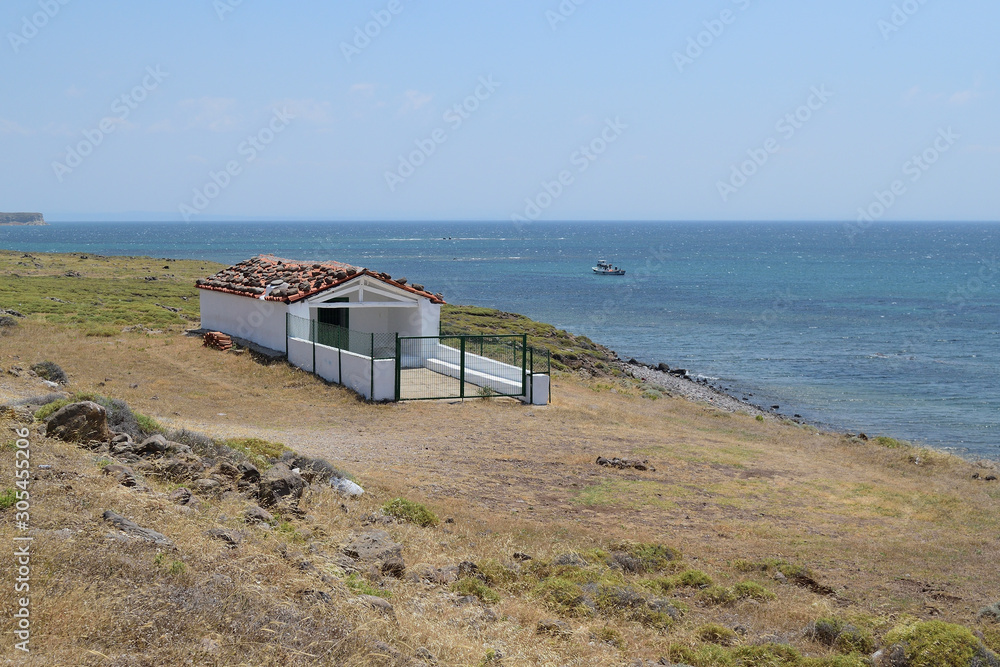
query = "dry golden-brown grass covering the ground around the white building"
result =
(0, 253, 1000, 665)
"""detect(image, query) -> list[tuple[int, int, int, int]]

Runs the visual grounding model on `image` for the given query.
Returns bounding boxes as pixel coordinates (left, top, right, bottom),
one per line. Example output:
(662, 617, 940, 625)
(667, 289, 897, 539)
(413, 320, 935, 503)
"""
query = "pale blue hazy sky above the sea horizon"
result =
(0, 0, 1000, 222)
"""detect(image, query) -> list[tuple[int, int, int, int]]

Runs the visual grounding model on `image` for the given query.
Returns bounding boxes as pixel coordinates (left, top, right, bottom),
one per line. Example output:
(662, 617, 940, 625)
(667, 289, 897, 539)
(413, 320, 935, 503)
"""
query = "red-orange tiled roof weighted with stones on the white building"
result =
(195, 255, 444, 303)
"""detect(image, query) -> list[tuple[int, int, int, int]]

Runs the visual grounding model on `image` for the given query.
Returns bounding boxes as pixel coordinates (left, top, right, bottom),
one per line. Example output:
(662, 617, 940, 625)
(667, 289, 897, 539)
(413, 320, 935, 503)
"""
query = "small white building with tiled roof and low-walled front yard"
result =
(197, 255, 549, 405)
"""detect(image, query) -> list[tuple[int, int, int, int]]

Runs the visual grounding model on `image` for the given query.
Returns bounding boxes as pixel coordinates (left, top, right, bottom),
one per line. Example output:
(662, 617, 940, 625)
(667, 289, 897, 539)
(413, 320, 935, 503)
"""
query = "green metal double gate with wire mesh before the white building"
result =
(396, 334, 534, 401)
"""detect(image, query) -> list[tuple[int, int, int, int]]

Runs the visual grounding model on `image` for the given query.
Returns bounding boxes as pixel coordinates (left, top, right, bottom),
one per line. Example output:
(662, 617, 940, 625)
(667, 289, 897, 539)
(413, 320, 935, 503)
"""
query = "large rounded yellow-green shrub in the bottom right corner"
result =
(885, 621, 996, 667)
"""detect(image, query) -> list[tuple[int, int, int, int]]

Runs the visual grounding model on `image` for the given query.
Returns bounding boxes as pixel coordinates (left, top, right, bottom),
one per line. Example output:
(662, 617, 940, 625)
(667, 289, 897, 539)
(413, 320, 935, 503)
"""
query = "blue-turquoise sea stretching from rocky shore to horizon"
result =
(0, 221, 1000, 460)
